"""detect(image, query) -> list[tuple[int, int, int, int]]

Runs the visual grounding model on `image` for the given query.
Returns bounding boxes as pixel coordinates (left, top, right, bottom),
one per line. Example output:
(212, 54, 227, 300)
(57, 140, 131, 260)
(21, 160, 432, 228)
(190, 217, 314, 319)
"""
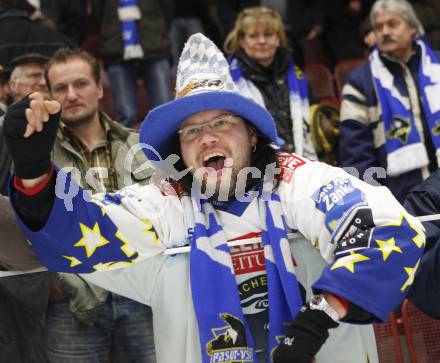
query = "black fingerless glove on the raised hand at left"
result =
(3, 97, 60, 179)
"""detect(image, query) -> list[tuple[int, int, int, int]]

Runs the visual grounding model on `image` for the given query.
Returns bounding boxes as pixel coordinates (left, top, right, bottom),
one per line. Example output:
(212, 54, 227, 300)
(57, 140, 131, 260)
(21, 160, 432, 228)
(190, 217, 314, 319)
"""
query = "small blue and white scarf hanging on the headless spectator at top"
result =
(118, 0, 144, 60)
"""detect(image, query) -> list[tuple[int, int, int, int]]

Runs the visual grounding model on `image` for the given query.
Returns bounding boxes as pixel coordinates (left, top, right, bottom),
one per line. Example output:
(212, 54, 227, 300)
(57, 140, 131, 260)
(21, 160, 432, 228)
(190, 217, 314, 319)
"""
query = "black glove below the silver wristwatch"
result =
(272, 306, 339, 363)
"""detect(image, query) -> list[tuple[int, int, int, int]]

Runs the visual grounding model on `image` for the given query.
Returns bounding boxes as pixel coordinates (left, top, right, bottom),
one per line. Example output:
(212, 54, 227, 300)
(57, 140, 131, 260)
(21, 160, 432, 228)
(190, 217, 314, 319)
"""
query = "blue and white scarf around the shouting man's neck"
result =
(190, 193, 302, 363)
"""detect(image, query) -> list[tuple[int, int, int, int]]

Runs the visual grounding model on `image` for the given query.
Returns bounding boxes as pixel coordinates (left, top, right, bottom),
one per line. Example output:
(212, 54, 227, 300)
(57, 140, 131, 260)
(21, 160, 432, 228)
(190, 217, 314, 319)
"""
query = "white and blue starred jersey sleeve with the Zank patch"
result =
(278, 154, 425, 321)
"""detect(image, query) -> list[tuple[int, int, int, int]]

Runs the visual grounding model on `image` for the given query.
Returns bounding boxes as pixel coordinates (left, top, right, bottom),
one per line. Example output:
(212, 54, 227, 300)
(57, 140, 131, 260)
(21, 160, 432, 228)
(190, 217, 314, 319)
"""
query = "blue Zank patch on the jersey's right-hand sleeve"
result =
(312, 177, 367, 237)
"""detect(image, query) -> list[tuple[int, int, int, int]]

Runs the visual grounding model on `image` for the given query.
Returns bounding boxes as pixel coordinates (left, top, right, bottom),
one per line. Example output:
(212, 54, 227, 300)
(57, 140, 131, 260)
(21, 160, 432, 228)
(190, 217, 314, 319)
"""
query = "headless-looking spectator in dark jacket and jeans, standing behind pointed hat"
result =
(92, 0, 173, 127)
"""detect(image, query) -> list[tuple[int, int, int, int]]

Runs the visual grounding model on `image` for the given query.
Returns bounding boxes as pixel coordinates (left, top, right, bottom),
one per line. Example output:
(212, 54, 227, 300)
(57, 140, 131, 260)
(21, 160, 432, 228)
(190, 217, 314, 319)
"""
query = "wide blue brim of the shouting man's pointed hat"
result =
(140, 91, 279, 161)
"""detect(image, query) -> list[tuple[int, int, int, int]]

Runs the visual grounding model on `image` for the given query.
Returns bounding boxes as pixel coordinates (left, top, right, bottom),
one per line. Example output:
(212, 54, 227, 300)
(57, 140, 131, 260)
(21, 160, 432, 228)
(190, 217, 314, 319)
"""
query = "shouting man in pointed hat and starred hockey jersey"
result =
(5, 33, 424, 363)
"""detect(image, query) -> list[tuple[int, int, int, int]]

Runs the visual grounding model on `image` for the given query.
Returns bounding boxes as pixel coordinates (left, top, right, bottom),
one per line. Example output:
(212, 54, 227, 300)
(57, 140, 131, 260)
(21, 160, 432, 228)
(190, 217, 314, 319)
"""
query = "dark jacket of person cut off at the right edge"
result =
(404, 169, 440, 319)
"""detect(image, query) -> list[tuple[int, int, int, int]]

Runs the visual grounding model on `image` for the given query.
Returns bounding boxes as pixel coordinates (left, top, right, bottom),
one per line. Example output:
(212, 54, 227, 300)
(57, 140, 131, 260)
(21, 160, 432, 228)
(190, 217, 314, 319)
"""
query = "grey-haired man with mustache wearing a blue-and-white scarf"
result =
(339, 0, 440, 202)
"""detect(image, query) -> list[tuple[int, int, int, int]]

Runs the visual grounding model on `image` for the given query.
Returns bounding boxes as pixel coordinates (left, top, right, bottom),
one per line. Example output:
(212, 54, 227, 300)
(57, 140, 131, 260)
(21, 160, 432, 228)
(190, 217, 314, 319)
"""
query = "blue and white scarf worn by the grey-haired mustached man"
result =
(370, 39, 440, 176)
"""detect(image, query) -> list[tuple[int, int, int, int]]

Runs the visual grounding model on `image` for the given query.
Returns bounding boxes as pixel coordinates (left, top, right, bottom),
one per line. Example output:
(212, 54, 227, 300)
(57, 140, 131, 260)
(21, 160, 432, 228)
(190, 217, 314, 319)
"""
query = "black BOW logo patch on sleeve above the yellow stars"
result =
(334, 208, 374, 256)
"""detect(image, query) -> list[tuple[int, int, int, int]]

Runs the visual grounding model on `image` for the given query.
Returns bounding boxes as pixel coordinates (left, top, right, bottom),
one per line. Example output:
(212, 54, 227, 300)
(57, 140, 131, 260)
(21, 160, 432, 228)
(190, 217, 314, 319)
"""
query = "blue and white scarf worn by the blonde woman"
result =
(228, 56, 317, 159)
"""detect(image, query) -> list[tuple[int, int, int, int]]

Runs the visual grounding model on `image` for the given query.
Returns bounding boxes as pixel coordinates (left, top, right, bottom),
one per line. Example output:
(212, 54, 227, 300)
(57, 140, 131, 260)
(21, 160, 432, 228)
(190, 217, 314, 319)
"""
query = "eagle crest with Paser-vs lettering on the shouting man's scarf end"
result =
(206, 313, 254, 363)
